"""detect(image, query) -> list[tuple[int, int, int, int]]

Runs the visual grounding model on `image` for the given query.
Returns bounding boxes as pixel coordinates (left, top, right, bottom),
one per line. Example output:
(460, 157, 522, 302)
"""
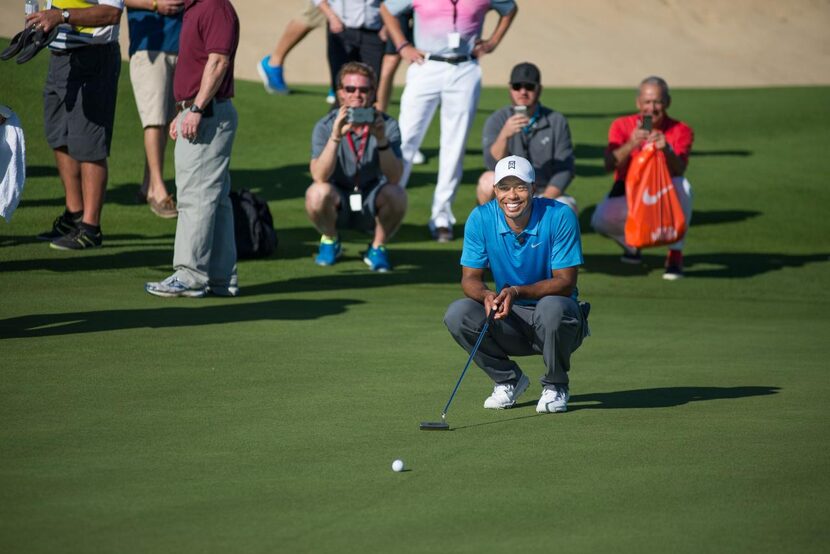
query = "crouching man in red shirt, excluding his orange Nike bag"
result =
(591, 77, 694, 280)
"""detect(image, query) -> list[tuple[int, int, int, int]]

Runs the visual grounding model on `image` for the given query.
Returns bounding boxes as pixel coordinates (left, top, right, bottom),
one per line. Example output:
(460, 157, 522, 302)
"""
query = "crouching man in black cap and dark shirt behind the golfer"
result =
(476, 63, 576, 211)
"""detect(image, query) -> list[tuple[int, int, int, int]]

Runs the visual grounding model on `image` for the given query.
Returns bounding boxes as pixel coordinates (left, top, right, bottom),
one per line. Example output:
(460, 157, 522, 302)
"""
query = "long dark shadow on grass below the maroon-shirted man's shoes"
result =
(0, 300, 363, 339)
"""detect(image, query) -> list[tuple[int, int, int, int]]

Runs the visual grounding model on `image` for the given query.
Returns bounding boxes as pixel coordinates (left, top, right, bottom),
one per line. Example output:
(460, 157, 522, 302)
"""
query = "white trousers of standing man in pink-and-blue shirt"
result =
(398, 60, 481, 228)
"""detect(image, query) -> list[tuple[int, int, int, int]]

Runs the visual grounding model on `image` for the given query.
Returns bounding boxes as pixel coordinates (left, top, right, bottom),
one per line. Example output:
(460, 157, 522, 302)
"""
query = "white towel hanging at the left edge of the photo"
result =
(0, 105, 26, 222)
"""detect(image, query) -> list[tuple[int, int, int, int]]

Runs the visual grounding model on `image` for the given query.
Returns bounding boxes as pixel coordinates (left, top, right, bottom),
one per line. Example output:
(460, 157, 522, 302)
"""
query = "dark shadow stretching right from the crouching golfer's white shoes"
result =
(568, 386, 781, 411)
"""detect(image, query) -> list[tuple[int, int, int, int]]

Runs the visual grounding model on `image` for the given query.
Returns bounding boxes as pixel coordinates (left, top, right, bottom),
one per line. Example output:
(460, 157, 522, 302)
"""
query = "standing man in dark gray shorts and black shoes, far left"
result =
(26, 0, 124, 250)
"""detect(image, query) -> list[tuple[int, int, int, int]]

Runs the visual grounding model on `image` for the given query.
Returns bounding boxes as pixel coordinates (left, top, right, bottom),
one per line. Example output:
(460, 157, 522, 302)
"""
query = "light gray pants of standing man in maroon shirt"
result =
(173, 100, 237, 287)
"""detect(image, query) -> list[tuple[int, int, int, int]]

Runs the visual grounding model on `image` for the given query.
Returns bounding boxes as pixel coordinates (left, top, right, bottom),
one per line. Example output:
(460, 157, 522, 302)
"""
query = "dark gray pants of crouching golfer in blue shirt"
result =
(444, 296, 588, 386)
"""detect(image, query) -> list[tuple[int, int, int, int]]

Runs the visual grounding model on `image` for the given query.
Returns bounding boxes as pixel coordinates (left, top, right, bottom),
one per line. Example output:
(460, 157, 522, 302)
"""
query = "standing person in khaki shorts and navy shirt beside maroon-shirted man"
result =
(125, 0, 184, 218)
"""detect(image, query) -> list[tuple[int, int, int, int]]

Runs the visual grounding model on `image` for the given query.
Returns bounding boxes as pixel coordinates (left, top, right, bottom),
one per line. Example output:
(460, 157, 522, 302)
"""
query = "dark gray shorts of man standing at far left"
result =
(43, 43, 121, 162)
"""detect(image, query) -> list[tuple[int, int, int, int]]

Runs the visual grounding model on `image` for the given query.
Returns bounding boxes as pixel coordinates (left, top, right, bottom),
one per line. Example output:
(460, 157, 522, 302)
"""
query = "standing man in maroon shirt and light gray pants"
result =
(144, 0, 239, 298)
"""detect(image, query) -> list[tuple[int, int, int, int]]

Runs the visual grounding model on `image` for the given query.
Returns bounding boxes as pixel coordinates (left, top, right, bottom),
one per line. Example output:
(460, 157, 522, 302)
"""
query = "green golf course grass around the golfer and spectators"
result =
(0, 43, 830, 554)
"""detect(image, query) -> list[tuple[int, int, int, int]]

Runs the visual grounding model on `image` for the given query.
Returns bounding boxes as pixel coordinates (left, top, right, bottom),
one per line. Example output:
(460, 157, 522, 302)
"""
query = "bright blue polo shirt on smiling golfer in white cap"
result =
(461, 198, 583, 305)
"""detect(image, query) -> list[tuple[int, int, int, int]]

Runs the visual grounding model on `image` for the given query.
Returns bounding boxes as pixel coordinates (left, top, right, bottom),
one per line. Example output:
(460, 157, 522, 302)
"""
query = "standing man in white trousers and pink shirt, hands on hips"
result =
(381, 0, 516, 242)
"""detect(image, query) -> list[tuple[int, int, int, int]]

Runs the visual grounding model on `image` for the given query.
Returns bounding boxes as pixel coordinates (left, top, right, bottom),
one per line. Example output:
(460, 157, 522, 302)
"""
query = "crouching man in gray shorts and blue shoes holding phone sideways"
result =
(305, 62, 407, 272)
